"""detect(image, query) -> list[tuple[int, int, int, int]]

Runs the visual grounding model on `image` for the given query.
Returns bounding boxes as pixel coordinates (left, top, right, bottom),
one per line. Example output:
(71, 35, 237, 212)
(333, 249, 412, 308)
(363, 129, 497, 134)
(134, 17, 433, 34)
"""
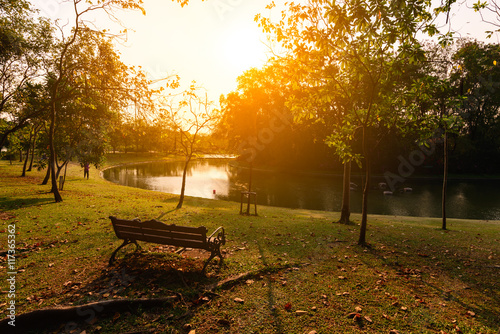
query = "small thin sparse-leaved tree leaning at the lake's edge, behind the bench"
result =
(160, 82, 219, 209)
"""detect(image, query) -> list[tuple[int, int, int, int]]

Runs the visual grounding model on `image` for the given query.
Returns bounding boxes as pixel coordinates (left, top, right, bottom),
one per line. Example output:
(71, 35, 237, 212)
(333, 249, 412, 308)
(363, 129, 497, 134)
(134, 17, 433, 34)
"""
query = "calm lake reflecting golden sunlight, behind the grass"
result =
(103, 159, 500, 220)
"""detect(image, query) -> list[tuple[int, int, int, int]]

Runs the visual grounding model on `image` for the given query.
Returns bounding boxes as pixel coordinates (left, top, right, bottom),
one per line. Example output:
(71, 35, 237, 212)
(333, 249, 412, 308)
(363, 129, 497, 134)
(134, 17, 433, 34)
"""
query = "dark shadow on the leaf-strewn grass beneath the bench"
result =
(38, 252, 224, 333)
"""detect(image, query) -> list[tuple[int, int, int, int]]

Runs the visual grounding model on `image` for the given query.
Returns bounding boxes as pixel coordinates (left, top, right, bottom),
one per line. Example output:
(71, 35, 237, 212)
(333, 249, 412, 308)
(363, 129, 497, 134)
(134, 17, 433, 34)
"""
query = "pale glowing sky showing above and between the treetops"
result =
(32, 0, 498, 107)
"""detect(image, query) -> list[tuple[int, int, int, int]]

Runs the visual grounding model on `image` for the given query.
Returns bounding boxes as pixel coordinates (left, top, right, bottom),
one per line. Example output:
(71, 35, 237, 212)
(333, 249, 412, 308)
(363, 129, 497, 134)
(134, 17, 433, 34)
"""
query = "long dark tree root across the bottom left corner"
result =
(0, 296, 179, 333)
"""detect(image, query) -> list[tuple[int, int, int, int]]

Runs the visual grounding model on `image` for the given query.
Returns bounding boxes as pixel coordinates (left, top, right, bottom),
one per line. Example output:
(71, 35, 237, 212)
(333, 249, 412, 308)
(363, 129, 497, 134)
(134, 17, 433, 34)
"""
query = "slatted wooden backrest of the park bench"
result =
(109, 217, 208, 249)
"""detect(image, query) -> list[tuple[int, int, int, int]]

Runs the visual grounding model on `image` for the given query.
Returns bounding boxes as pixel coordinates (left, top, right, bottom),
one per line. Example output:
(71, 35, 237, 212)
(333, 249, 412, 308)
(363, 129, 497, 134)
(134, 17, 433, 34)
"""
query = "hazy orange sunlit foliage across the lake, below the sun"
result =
(215, 60, 336, 168)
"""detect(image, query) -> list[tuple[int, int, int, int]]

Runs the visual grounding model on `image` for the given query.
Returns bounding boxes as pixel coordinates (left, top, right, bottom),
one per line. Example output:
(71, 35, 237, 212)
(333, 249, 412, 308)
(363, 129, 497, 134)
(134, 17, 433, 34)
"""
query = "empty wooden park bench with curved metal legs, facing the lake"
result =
(109, 216, 226, 272)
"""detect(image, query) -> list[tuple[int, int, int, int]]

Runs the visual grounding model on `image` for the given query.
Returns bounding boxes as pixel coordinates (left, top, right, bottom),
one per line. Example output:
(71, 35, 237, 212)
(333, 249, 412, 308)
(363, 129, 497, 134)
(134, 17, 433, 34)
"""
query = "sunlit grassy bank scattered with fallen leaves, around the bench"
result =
(0, 155, 500, 334)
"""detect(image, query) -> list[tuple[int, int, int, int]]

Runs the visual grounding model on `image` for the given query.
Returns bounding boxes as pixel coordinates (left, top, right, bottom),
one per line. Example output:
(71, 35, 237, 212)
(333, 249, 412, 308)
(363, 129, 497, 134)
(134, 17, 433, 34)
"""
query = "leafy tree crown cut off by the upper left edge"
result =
(0, 0, 53, 147)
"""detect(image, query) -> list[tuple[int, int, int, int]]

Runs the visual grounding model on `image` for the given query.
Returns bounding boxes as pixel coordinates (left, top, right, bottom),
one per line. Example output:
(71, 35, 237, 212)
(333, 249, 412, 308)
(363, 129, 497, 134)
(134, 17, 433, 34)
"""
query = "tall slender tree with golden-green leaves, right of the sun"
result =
(257, 0, 434, 245)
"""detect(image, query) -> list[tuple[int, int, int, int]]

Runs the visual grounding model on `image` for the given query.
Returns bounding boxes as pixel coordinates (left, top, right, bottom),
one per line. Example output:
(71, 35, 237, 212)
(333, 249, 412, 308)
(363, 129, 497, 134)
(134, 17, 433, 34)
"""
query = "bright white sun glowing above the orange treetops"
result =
(219, 27, 267, 72)
